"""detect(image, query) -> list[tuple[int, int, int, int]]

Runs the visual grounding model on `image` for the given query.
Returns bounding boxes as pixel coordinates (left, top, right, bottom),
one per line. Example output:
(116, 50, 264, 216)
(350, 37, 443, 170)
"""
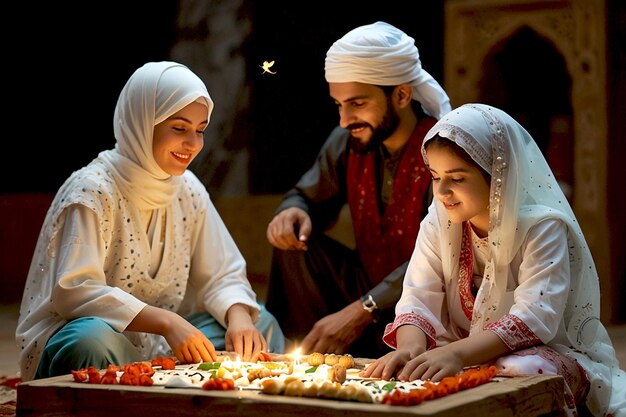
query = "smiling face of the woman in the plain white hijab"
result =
(152, 101, 209, 176)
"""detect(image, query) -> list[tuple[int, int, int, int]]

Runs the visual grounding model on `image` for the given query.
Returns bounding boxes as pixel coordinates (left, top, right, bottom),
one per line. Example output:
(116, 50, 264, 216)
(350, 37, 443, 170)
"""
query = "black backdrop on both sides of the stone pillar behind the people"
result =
(0, 0, 443, 193)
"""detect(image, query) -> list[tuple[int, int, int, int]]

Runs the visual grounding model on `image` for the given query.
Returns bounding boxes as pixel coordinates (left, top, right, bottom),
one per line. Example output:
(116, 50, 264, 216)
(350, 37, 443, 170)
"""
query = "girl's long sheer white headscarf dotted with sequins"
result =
(422, 104, 626, 412)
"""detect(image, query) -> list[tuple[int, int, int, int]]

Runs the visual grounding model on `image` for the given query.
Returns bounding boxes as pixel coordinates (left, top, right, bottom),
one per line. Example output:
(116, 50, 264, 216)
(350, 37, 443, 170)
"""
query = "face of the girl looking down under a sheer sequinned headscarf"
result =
(426, 144, 489, 237)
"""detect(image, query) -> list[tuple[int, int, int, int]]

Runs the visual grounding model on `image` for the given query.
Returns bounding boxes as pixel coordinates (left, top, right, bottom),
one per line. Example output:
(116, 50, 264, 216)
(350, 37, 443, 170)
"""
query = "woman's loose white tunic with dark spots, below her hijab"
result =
(16, 166, 259, 380)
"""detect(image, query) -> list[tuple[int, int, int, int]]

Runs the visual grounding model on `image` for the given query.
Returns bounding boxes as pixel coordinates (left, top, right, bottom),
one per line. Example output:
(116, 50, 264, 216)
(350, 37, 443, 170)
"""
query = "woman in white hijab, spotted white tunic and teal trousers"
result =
(16, 62, 284, 380)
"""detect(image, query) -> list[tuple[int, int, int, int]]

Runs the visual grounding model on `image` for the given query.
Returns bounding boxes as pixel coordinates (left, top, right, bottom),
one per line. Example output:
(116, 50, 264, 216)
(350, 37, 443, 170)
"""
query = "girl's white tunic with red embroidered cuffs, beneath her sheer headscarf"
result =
(396, 212, 569, 348)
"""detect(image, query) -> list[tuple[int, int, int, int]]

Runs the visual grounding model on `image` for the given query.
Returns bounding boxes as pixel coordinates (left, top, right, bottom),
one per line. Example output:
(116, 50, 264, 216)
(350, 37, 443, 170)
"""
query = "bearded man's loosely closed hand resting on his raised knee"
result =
(266, 207, 313, 250)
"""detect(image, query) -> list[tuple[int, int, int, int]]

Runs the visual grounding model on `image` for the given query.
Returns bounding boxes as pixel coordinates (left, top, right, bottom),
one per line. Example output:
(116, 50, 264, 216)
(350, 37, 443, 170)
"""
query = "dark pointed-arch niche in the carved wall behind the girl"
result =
(478, 26, 575, 204)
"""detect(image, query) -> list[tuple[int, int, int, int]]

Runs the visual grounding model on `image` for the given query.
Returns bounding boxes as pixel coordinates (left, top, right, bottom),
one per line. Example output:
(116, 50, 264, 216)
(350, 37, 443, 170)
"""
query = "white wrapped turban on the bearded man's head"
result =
(325, 22, 450, 119)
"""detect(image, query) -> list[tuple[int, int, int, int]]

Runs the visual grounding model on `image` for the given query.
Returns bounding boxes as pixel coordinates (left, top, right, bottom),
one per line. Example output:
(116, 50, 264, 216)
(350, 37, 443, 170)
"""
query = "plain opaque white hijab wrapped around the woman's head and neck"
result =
(98, 61, 213, 210)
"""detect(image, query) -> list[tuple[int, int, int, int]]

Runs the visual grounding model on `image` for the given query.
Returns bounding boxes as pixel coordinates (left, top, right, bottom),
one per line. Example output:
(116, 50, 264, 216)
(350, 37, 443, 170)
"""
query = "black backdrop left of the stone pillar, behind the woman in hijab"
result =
(6, 1, 176, 192)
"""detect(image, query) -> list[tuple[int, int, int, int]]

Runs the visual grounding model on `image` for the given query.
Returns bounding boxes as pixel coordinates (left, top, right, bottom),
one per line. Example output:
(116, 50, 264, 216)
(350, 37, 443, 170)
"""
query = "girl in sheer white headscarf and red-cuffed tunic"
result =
(364, 104, 626, 416)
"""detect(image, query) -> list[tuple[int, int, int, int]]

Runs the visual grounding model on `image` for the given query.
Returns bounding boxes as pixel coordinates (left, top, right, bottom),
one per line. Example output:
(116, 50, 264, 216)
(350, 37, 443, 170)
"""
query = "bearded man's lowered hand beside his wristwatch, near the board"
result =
(301, 300, 372, 354)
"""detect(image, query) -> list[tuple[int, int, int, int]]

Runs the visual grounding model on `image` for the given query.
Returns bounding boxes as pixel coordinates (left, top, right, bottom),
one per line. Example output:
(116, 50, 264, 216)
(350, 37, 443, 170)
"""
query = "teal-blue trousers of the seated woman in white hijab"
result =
(35, 304, 285, 379)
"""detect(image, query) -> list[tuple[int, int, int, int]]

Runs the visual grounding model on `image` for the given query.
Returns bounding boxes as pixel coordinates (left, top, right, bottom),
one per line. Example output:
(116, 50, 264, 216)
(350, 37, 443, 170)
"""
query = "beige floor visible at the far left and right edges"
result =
(0, 304, 626, 375)
